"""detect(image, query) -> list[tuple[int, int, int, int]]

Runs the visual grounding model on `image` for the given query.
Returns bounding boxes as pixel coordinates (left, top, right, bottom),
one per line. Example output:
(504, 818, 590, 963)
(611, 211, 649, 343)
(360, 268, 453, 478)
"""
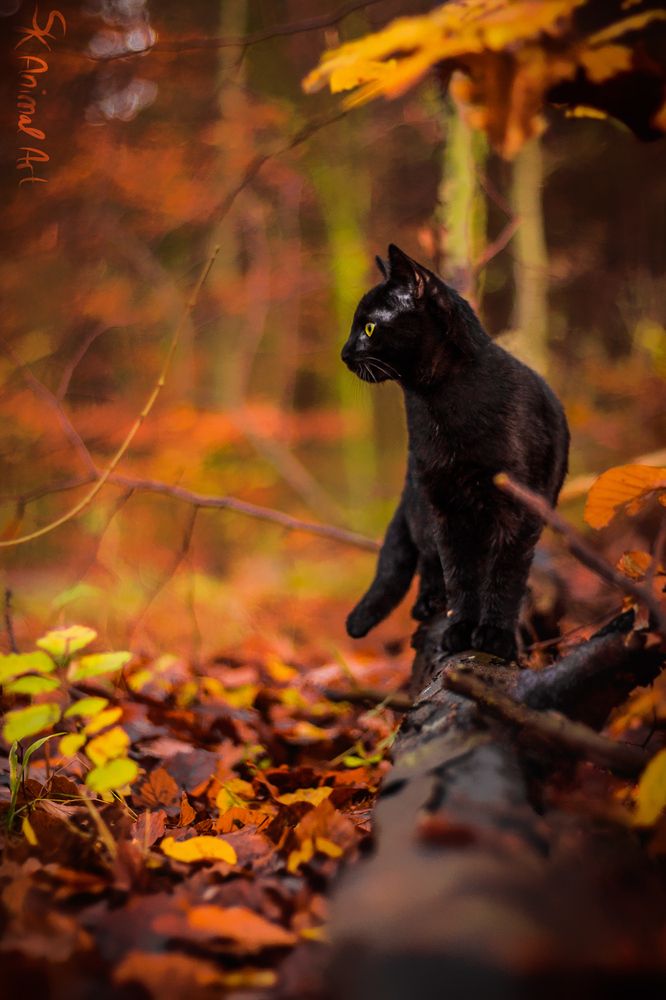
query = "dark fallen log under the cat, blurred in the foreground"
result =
(331, 625, 666, 1000)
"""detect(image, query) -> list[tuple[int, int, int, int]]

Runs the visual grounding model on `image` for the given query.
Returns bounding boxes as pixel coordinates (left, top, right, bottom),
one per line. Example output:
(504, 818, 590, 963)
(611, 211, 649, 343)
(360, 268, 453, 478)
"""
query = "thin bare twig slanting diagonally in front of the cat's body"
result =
(495, 472, 666, 637)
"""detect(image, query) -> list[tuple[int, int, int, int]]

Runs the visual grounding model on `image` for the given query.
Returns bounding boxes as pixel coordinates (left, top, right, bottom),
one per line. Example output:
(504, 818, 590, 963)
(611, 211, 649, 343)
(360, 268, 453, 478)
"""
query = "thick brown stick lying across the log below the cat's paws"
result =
(442, 670, 650, 778)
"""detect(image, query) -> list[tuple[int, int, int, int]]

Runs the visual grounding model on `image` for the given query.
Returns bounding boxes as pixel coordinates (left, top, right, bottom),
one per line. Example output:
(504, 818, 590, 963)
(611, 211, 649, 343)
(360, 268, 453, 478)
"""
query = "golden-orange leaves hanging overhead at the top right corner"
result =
(303, 0, 666, 158)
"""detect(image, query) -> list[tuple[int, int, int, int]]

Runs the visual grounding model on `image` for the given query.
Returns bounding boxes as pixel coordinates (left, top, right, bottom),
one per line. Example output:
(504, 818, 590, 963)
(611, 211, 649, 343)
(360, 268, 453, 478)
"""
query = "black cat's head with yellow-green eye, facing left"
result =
(342, 243, 462, 386)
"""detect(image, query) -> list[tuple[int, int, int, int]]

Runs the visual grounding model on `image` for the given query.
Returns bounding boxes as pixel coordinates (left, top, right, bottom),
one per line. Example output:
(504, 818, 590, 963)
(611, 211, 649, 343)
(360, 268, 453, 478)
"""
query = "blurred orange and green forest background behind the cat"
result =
(0, 0, 666, 661)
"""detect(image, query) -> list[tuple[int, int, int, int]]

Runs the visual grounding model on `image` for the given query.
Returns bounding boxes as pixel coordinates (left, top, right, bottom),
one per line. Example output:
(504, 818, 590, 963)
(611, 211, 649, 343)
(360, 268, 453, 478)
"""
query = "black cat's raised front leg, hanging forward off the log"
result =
(347, 500, 418, 639)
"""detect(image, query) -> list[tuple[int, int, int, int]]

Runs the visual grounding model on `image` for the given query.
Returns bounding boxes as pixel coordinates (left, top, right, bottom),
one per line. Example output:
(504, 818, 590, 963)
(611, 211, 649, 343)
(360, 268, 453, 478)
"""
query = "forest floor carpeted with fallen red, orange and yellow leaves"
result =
(0, 544, 666, 1000)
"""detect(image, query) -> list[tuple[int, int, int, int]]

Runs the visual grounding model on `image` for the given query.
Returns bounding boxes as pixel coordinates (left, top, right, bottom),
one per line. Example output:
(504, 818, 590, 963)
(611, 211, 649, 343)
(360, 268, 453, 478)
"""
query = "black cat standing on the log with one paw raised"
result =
(342, 244, 569, 658)
